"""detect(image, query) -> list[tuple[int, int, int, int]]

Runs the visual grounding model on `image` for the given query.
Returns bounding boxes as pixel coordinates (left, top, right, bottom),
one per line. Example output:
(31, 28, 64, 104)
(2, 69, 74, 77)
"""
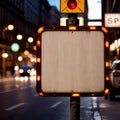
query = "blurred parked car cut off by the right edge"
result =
(109, 60, 120, 100)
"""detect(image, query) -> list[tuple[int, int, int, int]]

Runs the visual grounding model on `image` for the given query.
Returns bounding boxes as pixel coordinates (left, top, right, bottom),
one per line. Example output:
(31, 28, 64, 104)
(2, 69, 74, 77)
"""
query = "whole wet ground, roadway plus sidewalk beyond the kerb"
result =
(0, 77, 120, 120)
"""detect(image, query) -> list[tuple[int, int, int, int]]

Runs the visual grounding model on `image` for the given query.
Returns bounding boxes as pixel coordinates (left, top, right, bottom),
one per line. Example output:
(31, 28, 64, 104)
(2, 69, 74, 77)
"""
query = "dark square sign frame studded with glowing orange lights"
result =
(36, 26, 109, 96)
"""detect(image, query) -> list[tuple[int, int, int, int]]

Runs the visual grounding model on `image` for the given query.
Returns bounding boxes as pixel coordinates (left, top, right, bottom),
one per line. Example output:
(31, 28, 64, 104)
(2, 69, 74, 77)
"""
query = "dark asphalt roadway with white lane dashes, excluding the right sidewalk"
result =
(0, 77, 92, 120)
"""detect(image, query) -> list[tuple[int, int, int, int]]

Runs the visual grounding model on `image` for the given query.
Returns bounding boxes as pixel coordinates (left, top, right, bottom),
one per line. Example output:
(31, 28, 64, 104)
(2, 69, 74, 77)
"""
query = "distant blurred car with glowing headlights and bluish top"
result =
(19, 65, 32, 76)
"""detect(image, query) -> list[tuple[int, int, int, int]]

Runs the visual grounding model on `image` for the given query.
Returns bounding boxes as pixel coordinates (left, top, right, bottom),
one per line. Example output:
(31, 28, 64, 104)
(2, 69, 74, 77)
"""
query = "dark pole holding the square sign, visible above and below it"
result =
(66, 14, 80, 120)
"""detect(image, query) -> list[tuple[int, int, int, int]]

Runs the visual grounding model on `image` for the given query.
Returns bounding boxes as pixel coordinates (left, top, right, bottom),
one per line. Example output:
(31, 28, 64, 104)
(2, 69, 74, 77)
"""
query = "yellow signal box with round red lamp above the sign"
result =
(60, 0, 84, 13)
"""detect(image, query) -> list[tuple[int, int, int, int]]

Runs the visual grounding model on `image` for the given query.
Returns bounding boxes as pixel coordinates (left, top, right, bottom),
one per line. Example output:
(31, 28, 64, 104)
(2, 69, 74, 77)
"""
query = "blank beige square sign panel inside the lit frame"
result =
(38, 26, 109, 96)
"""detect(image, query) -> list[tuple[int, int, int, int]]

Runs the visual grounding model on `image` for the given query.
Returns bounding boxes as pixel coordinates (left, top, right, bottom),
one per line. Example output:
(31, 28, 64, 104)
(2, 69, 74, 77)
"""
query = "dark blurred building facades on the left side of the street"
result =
(0, 0, 60, 77)
